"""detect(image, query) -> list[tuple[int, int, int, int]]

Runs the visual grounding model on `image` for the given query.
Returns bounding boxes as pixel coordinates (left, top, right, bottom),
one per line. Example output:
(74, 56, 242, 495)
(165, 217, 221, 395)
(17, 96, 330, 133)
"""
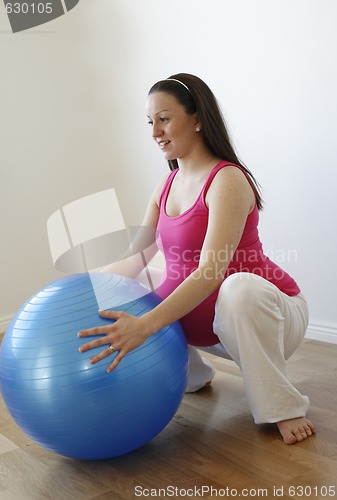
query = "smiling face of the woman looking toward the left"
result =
(146, 92, 200, 160)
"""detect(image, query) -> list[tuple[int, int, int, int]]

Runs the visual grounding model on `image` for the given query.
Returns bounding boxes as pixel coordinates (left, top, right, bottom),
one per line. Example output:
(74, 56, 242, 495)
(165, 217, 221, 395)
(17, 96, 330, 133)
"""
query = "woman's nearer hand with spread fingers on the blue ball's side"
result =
(77, 311, 152, 373)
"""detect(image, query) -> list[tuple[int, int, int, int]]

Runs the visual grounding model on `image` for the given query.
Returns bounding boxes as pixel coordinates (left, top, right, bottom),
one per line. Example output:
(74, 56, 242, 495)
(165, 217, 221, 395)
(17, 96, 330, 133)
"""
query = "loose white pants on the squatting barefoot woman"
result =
(187, 273, 309, 424)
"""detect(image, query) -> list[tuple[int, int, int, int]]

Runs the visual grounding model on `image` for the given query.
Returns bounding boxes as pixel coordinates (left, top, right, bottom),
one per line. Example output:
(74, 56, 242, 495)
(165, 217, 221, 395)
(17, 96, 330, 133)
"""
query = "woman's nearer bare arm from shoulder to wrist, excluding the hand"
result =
(138, 167, 255, 334)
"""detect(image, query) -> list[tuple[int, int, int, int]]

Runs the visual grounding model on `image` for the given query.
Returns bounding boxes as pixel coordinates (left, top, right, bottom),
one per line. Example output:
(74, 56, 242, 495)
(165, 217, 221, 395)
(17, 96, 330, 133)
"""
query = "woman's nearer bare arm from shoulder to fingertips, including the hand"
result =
(79, 167, 255, 371)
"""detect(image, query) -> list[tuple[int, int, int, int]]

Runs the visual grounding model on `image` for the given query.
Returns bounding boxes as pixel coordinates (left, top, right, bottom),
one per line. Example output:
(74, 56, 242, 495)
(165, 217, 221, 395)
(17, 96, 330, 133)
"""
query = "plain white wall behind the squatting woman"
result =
(0, 0, 337, 342)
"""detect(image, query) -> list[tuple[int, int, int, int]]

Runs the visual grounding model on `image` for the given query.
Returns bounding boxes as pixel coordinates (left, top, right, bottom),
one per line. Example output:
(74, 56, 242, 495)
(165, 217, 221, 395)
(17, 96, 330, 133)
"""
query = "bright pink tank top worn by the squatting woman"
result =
(157, 161, 300, 346)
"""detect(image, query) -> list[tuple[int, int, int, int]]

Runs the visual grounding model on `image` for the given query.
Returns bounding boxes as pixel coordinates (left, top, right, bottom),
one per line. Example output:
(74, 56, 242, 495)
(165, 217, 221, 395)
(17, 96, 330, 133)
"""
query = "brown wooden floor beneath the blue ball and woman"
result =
(0, 340, 337, 500)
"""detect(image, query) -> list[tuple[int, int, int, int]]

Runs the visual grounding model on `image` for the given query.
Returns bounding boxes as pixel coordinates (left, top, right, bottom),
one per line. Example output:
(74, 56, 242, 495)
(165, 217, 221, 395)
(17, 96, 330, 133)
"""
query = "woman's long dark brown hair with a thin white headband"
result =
(149, 73, 263, 210)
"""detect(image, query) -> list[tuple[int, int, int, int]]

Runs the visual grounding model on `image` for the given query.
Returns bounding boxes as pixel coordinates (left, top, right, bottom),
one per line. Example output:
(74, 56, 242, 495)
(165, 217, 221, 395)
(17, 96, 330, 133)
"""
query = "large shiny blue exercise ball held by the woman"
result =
(0, 273, 188, 460)
